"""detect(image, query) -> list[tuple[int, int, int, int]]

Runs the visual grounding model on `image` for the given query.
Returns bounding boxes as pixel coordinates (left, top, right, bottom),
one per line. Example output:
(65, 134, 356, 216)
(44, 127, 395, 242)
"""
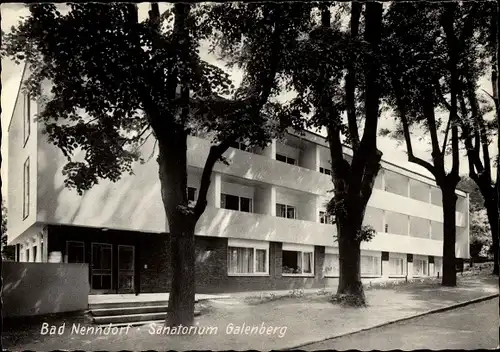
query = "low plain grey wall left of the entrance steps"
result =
(2, 262, 89, 318)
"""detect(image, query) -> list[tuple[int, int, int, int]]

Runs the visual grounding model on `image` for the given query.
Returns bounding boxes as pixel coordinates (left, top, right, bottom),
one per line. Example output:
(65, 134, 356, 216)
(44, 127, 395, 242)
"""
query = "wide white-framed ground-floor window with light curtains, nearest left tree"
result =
(227, 243, 268, 275)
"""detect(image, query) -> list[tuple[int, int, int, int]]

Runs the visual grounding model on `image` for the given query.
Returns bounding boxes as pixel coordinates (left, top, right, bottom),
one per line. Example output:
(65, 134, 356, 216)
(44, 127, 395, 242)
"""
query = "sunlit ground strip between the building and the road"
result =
(2, 275, 498, 351)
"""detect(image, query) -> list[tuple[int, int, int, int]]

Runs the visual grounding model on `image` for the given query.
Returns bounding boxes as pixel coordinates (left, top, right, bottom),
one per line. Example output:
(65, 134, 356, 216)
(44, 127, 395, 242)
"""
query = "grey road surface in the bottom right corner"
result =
(301, 298, 499, 351)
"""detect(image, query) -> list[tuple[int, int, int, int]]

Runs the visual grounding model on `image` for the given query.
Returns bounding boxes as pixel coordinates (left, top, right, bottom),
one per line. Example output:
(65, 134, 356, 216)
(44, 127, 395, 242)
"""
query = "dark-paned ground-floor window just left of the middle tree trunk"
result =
(282, 245, 314, 274)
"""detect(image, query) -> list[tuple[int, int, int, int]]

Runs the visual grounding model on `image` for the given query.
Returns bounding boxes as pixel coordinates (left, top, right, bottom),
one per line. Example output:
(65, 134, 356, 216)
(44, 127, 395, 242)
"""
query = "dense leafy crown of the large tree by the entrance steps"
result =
(2, 3, 310, 193)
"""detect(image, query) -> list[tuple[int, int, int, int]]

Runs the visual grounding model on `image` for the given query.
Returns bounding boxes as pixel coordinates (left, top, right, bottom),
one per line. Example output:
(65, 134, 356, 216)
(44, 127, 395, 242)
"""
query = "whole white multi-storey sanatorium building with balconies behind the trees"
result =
(8, 70, 469, 293)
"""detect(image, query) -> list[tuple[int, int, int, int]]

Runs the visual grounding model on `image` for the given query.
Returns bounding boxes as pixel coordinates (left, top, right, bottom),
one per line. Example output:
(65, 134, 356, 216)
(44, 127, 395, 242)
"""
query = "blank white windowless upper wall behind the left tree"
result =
(37, 128, 166, 233)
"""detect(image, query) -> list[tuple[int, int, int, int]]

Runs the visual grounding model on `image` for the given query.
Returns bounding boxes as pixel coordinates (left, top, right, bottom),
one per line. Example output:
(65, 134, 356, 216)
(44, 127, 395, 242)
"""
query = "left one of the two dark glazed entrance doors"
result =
(91, 243, 113, 293)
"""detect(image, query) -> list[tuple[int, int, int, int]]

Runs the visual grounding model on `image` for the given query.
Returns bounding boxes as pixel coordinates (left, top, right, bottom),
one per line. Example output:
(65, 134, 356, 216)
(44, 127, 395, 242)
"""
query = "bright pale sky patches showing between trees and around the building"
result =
(0, 3, 496, 201)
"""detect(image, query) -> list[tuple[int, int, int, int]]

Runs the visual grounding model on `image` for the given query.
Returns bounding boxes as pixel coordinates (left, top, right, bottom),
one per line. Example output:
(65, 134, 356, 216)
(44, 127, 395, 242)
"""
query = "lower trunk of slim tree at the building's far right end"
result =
(441, 186, 457, 286)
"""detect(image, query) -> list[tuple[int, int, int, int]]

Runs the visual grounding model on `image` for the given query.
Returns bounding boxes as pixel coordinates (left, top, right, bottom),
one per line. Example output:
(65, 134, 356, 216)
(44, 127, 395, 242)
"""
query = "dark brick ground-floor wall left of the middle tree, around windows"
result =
(48, 227, 344, 293)
